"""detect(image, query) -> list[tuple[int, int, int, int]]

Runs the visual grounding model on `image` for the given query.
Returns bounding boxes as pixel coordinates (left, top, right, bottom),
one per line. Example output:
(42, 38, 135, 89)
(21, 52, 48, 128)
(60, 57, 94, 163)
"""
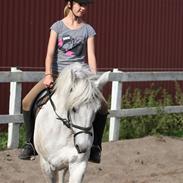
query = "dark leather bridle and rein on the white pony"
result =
(47, 88, 93, 153)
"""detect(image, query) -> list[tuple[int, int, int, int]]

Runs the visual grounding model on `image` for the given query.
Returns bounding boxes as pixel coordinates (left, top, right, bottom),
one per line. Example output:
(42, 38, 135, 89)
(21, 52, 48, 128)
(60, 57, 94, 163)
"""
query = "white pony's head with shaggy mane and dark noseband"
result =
(55, 63, 109, 153)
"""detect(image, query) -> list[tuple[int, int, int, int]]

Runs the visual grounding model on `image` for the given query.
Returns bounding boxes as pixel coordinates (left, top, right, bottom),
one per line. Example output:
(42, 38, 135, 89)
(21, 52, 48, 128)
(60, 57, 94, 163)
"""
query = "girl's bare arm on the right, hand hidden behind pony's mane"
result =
(87, 37, 97, 74)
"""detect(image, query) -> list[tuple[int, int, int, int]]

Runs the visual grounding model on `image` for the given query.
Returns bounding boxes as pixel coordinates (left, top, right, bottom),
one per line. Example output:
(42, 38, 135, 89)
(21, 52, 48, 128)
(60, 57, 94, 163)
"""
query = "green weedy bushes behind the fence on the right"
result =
(104, 82, 183, 140)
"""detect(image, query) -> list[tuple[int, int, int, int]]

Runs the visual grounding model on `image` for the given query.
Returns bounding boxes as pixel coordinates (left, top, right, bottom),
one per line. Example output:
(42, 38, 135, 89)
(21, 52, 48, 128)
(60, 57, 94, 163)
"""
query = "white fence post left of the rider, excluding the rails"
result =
(7, 67, 22, 149)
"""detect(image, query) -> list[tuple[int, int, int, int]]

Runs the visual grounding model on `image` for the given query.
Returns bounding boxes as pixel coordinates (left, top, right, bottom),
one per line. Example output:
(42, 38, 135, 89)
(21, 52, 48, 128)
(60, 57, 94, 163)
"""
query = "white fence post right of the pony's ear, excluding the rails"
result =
(109, 69, 122, 141)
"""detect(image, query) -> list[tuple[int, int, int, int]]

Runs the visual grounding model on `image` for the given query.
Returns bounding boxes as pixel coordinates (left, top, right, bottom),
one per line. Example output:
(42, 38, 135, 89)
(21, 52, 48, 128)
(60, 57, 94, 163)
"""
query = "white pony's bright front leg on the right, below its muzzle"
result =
(69, 160, 88, 183)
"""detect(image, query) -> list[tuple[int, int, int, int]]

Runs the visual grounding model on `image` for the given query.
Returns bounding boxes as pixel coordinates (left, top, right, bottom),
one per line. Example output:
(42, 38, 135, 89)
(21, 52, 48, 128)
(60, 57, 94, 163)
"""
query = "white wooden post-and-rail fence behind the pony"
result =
(0, 68, 183, 148)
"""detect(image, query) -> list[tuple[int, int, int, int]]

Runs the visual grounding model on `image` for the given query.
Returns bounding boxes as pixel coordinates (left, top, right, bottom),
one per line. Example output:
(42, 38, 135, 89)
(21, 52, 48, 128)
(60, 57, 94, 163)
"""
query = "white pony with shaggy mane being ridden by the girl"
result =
(34, 63, 109, 183)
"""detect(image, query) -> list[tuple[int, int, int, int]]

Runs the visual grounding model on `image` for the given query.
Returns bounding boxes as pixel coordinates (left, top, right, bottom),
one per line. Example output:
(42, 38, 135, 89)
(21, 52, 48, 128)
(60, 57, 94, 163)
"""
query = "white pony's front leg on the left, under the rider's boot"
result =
(40, 157, 58, 183)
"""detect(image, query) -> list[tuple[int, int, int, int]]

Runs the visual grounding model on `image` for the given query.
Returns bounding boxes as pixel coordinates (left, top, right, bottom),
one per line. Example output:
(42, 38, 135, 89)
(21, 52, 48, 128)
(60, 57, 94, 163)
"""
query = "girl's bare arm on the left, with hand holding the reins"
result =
(43, 30, 57, 87)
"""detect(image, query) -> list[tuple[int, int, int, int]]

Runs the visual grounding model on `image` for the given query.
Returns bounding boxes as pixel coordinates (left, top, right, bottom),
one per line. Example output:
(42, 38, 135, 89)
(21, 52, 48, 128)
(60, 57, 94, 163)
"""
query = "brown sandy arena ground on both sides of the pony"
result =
(0, 137, 183, 183)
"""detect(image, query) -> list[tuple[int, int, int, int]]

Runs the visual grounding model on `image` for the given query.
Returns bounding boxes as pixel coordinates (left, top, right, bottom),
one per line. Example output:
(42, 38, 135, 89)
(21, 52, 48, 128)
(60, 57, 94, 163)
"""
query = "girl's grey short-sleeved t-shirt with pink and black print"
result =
(50, 20, 96, 72)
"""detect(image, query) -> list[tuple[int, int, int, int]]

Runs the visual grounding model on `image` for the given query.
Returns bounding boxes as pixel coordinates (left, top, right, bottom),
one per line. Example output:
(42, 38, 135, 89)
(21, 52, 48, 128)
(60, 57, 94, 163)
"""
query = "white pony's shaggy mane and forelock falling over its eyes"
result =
(55, 63, 104, 110)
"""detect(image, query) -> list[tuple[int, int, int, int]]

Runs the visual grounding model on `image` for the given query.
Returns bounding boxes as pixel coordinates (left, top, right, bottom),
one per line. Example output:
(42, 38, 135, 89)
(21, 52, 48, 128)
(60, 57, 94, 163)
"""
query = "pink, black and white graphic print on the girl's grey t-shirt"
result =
(58, 35, 84, 57)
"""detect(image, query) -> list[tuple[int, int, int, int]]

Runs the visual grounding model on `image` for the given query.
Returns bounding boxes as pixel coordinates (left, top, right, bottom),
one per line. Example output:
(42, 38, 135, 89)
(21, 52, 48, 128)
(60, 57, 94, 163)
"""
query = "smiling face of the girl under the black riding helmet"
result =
(72, 1, 87, 17)
